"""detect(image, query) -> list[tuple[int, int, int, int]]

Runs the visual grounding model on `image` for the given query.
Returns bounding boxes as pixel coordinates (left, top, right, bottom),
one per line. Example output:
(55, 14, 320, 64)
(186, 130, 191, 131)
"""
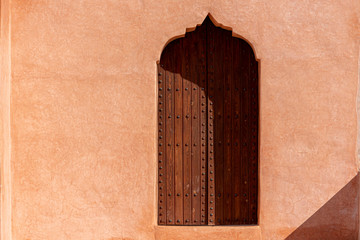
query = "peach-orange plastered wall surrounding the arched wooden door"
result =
(1, 0, 360, 240)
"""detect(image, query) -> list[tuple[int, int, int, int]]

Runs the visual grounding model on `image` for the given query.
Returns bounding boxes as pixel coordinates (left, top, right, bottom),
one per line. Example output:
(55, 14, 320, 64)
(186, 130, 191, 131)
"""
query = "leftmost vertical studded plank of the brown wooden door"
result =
(158, 64, 166, 225)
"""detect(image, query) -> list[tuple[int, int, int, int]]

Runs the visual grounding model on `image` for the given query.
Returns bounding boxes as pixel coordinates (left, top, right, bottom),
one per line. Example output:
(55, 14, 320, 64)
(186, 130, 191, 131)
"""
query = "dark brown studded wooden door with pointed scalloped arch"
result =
(158, 17, 259, 225)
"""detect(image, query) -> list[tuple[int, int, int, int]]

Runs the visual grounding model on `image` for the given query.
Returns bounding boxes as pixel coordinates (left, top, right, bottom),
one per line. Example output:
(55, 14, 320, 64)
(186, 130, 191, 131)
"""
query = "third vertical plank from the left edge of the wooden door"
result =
(173, 40, 184, 225)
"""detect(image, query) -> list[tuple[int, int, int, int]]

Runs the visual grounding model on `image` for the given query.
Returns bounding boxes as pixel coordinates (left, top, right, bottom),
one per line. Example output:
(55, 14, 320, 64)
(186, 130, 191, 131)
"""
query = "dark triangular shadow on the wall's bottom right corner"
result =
(286, 173, 359, 240)
